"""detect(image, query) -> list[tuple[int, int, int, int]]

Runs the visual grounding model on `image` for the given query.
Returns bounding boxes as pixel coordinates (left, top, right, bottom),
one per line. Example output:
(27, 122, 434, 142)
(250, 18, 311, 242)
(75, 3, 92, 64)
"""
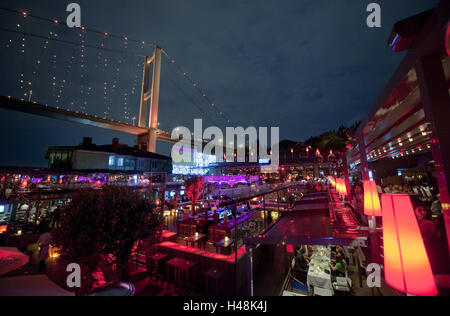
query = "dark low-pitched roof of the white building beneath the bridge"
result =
(47, 144, 172, 160)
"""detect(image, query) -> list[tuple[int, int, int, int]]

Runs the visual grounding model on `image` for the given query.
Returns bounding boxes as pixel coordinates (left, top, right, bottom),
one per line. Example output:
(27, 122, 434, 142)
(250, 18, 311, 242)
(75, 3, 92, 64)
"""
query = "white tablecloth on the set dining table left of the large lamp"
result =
(307, 246, 333, 291)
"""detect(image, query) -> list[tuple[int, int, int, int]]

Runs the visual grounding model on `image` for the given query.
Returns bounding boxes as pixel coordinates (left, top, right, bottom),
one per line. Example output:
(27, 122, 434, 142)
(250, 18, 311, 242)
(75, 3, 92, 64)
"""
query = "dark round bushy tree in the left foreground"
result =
(54, 186, 163, 292)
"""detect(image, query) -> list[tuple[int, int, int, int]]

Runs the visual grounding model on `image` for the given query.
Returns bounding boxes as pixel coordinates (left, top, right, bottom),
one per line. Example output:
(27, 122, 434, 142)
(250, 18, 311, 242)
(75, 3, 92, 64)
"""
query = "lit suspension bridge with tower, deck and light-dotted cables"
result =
(0, 7, 231, 152)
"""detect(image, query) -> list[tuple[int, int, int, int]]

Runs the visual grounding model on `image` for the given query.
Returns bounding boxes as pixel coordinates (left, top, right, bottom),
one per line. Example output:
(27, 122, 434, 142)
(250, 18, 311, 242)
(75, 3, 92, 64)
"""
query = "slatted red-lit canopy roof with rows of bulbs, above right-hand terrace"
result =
(348, 1, 450, 164)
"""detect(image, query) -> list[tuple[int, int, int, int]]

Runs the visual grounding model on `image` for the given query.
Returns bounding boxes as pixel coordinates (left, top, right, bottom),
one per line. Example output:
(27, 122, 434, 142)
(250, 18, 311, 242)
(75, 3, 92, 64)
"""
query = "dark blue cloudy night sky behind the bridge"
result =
(0, 0, 438, 167)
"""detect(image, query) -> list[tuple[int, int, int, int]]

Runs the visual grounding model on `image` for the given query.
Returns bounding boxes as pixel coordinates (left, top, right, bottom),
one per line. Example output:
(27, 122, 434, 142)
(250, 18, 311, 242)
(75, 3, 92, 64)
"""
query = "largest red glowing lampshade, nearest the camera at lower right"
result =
(382, 194, 438, 296)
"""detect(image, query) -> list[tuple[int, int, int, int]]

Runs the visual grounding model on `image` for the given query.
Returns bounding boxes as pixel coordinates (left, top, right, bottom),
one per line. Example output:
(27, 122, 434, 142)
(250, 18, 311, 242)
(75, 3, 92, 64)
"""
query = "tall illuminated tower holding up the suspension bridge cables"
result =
(138, 46, 162, 153)
